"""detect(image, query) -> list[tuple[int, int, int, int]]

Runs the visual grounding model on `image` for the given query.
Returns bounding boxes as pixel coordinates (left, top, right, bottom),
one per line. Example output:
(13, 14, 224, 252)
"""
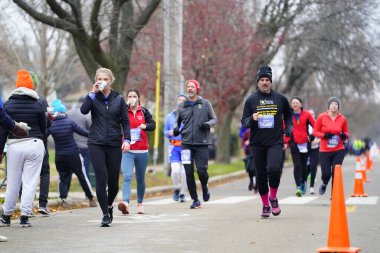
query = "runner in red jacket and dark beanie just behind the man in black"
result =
(289, 97, 315, 197)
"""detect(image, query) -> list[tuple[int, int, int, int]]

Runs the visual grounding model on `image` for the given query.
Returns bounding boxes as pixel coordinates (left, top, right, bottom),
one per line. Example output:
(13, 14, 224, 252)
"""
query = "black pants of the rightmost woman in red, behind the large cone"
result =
(319, 149, 346, 185)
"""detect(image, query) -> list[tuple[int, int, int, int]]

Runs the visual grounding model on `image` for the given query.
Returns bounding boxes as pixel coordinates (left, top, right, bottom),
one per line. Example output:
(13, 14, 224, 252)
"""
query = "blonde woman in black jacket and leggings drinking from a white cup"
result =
(80, 68, 131, 227)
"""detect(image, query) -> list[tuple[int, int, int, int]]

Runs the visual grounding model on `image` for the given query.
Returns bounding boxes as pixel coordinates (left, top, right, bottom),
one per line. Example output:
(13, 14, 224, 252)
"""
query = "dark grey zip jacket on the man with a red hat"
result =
(174, 96, 216, 145)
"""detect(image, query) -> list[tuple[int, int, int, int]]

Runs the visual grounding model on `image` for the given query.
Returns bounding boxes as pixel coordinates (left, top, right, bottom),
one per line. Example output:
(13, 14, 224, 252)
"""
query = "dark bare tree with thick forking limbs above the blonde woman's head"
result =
(13, 0, 161, 91)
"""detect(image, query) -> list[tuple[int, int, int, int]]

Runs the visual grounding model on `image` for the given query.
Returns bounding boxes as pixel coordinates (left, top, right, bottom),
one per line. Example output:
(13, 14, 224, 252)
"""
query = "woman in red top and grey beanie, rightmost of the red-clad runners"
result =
(313, 97, 349, 195)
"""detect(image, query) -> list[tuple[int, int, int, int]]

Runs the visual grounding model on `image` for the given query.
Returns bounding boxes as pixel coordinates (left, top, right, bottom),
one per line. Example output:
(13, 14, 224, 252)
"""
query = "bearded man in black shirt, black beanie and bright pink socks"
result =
(241, 66, 293, 218)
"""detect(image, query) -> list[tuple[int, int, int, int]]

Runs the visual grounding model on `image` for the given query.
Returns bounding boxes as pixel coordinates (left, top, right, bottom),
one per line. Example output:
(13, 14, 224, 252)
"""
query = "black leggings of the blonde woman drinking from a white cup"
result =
(88, 144, 121, 215)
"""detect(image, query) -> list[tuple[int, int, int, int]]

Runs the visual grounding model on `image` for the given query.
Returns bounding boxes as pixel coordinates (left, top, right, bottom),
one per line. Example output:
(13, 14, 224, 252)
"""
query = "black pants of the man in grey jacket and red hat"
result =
(182, 145, 208, 200)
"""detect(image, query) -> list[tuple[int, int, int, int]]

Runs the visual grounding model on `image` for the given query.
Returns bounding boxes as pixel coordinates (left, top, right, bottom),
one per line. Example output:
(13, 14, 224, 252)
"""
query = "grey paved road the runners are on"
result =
(0, 155, 380, 253)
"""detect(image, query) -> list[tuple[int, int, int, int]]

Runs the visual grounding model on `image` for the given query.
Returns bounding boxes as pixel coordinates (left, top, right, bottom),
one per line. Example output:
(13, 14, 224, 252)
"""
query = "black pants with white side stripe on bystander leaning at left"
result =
(55, 154, 94, 199)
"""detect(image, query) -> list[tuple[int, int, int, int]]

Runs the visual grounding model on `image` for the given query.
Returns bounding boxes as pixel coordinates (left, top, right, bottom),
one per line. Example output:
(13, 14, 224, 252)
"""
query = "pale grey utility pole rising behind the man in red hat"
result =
(163, 0, 184, 172)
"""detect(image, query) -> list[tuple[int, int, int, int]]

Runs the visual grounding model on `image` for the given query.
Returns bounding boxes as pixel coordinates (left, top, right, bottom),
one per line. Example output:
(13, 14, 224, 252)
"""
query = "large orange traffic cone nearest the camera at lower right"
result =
(317, 165, 361, 253)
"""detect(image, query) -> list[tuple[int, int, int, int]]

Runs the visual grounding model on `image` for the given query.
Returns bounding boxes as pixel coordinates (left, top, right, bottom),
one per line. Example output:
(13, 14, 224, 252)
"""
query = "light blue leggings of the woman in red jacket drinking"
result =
(121, 152, 149, 203)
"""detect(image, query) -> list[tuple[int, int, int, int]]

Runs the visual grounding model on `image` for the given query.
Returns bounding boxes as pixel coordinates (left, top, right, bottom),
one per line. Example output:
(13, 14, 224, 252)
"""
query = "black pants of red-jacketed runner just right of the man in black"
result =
(290, 142, 309, 187)
